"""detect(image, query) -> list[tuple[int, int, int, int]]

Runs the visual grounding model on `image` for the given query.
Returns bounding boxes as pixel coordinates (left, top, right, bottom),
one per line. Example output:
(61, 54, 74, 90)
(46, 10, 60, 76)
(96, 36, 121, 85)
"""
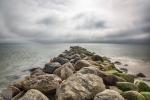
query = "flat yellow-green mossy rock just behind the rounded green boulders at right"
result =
(114, 73, 135, 83)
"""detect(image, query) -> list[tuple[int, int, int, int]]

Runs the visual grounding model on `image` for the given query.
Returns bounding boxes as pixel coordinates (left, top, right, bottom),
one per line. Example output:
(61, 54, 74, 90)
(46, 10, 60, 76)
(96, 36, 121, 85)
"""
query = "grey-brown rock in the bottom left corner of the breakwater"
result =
(1, 86, 20, 99)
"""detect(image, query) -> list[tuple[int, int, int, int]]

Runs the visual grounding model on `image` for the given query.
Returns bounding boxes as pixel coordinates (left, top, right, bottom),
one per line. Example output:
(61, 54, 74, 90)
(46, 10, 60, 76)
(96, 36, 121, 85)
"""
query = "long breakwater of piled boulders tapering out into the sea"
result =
(0, 46, 150, 100)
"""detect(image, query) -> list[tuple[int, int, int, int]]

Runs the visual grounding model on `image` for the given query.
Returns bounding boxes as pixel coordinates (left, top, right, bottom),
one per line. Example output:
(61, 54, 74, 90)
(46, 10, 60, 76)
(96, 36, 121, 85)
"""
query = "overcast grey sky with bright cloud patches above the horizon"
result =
(0, 0, 150, 43)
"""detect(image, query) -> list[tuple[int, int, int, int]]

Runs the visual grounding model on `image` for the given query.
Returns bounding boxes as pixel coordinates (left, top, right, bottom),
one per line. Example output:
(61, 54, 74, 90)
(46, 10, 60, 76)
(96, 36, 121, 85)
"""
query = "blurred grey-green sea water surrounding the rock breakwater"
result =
(0, 43, 150, 89)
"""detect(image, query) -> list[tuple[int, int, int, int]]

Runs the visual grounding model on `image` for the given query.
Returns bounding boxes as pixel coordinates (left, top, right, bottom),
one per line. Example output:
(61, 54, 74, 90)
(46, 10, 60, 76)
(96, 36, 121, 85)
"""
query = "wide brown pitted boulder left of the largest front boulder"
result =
(21, 74, 62, 92)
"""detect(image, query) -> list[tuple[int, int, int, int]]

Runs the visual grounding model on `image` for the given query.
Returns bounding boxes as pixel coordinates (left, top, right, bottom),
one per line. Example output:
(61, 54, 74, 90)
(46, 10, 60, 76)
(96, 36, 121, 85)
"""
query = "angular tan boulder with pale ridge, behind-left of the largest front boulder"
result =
(54, 63, 75, 80)
